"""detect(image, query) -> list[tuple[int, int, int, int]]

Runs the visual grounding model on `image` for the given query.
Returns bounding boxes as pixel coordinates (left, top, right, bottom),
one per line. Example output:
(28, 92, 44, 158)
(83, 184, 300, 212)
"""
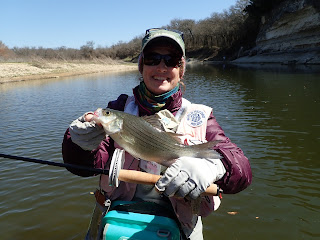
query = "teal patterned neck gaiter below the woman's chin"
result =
(138, 82, 179, 113)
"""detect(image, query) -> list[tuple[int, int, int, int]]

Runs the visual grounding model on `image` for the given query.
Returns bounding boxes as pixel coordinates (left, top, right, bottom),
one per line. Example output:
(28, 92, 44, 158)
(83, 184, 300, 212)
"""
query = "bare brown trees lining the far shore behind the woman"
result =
(0, 0, 290, 60)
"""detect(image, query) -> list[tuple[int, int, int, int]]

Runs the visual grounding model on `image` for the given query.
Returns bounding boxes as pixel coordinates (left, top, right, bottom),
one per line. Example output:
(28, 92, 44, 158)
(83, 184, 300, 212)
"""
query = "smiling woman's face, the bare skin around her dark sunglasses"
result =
(142, 47, 180, 95)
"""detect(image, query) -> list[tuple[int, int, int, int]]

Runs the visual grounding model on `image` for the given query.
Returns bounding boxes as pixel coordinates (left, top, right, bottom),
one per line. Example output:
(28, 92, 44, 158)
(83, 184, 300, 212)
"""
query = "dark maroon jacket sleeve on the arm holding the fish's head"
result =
(62, 94, 128, 177)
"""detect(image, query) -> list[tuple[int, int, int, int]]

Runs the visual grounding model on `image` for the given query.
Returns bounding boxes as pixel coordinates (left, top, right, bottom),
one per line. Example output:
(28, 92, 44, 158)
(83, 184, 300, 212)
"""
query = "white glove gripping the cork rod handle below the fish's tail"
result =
(155, 157, 226, 199)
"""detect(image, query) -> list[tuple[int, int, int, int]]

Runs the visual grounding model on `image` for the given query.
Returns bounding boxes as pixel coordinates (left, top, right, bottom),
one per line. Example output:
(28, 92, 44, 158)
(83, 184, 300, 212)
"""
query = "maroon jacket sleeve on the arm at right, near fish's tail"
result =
(206, 113, 252, 193)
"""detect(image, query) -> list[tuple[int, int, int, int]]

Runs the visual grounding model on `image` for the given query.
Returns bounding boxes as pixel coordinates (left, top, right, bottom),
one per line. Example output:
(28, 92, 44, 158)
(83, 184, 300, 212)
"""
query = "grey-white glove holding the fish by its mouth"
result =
(69, 112, 106, 151)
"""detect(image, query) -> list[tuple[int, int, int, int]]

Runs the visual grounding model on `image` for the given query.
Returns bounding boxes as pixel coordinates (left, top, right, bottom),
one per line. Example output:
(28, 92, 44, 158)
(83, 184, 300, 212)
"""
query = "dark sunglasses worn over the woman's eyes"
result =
(143, 53, 181, 67)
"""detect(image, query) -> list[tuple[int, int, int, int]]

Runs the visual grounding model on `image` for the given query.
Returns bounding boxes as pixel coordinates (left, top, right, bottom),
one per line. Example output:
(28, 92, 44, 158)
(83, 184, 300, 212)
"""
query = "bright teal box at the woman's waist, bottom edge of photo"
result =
(101, 202, 180, 240)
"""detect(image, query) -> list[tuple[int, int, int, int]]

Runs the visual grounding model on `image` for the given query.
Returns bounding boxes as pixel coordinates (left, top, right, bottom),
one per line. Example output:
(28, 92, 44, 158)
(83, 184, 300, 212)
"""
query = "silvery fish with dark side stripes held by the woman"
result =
(94, 108, 221, 166)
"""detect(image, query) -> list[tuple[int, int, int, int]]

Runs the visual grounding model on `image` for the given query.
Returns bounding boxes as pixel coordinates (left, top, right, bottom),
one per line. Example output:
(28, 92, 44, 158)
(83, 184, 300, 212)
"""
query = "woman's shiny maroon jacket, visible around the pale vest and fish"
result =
(62, 87, 252, 193)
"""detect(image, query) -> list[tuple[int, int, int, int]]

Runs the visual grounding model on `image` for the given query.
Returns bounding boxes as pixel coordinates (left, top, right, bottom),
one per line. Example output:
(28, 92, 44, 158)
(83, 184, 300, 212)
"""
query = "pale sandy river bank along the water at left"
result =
(0, 61, 138, 84)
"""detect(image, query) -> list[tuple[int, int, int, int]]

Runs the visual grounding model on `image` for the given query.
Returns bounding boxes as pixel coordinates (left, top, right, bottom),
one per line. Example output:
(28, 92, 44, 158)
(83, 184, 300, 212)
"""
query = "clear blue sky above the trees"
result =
(0, 0, 236, 48)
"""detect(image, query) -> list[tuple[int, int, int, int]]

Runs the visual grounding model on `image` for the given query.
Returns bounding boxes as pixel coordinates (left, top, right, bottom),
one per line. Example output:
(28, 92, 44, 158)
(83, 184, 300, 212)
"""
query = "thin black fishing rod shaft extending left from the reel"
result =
(0, 153, 109, 175)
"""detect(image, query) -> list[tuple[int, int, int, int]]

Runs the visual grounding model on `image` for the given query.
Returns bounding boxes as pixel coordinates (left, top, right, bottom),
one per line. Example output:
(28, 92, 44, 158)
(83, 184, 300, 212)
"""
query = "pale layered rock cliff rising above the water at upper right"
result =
(232, 0, 320, 65)
